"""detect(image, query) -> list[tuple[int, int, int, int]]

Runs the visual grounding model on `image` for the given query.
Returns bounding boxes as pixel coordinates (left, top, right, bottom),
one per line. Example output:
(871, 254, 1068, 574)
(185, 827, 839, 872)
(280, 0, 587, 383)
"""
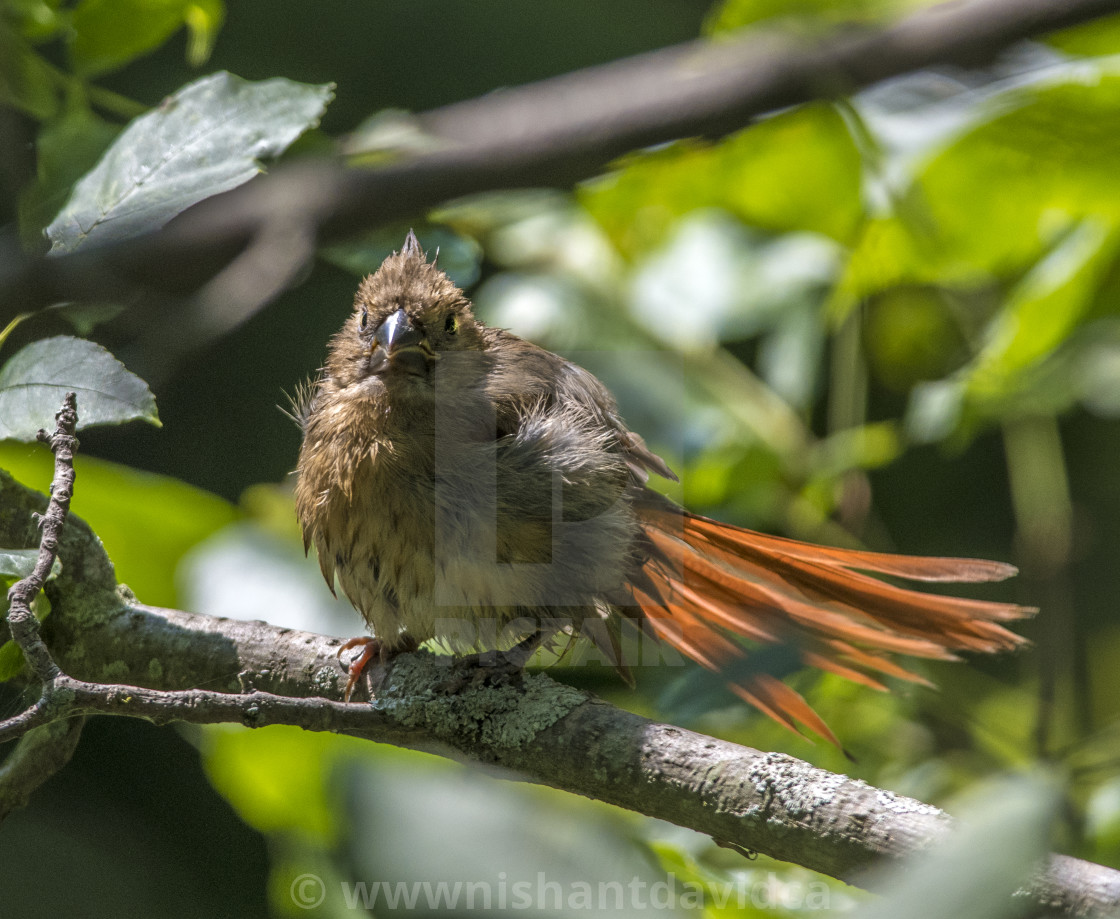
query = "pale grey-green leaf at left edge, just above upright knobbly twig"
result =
(0, 335, 160, 441)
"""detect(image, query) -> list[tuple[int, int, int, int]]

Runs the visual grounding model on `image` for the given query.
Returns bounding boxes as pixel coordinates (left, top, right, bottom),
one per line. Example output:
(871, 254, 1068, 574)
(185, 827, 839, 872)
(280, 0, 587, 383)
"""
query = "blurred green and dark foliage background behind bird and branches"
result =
(0, 0, 1120, 917)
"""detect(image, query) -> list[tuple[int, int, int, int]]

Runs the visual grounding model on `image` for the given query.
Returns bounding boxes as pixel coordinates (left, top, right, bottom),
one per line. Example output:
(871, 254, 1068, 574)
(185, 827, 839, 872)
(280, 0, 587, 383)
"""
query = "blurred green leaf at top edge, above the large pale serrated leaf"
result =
(71, 0, 224, 76)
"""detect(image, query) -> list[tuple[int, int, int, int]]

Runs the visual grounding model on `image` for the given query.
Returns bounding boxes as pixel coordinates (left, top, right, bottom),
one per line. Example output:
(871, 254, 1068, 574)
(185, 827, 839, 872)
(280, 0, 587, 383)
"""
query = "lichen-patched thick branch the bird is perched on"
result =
(0, 458, 1120, 916)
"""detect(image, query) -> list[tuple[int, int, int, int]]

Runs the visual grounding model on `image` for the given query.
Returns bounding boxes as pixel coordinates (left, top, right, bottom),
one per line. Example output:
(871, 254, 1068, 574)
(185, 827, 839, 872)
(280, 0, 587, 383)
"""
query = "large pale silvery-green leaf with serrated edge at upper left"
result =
(47, 72, 334, 252)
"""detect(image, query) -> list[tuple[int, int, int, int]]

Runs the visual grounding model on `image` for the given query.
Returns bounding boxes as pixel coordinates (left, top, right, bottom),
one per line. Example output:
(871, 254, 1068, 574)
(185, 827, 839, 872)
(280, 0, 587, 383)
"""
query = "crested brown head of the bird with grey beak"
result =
(325, 232, 485, 388)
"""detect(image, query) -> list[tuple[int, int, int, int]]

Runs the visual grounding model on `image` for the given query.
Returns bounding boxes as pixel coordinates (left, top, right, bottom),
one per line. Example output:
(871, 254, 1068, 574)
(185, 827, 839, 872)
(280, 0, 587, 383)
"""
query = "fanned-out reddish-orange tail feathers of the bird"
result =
(631, 491, 1036, 745)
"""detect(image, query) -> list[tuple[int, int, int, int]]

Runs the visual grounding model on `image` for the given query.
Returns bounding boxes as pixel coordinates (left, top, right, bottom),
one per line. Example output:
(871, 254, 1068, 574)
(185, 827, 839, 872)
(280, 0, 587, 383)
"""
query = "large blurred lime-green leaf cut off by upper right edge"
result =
(833, 56, 1120, 311)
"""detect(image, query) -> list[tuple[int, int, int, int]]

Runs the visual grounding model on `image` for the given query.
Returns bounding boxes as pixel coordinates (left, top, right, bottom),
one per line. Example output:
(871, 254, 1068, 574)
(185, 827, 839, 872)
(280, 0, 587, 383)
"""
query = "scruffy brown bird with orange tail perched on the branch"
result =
(295, 232, 1036, 747)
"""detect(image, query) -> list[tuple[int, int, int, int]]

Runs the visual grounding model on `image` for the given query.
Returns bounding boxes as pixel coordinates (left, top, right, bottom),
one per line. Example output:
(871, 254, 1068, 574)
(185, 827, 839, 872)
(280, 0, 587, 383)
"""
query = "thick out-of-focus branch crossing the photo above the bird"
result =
(0, 0, 1120, 315)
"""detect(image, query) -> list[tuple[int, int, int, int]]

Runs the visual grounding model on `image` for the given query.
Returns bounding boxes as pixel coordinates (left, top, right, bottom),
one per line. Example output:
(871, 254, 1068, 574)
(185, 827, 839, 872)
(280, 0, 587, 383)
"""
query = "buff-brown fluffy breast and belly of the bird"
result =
(297, 382, 631, 645)
